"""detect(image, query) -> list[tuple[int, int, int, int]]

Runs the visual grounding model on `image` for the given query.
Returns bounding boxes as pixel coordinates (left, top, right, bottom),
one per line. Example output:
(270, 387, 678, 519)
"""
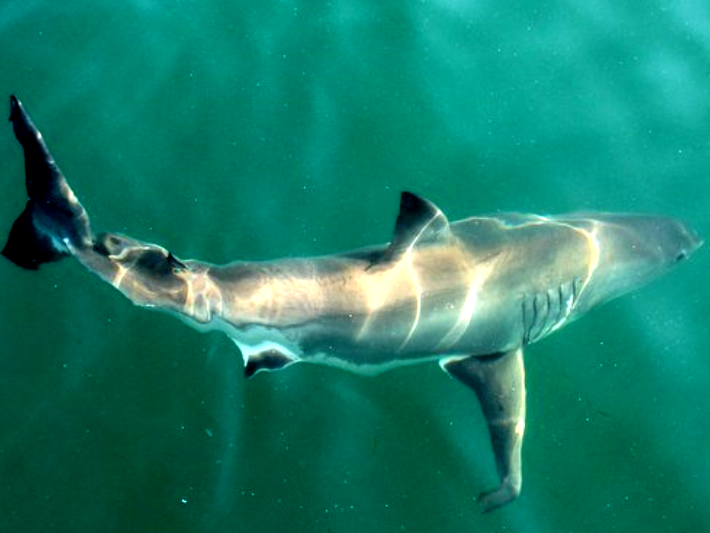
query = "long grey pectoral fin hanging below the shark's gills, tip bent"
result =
(441, 348, 525, 513)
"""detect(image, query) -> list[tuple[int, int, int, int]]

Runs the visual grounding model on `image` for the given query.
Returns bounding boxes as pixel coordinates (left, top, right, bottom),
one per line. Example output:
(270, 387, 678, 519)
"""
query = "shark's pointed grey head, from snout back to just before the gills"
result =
(585, 214, 702, 305)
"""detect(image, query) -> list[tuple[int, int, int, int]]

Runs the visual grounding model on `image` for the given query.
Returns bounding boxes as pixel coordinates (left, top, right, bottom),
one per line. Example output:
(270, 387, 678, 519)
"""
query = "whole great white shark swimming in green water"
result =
(2, 96, 701, 512)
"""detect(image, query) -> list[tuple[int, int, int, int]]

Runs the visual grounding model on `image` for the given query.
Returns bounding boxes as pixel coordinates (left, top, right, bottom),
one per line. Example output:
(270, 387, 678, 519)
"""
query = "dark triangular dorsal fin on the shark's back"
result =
(385, 191, 451, 259)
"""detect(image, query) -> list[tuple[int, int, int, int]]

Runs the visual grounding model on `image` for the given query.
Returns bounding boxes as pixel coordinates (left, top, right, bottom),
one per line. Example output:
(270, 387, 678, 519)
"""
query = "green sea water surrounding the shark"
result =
(0, 0, 710, 533)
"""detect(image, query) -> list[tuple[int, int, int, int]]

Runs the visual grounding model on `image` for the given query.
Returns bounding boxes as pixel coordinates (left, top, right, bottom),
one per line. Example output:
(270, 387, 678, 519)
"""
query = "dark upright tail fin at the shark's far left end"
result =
(2, 95, 92, 270)
